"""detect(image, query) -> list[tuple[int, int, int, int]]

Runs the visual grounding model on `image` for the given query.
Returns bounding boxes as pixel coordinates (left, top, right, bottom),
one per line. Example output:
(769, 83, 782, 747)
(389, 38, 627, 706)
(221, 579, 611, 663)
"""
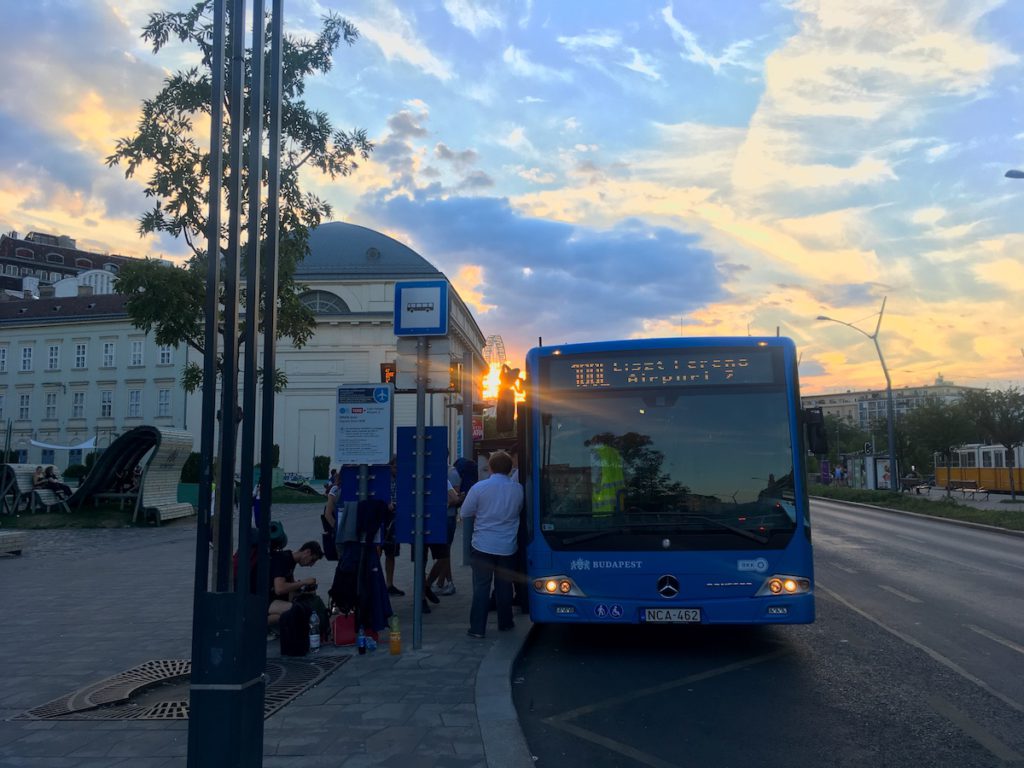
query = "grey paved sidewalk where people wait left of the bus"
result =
(0, 503, 532, 768)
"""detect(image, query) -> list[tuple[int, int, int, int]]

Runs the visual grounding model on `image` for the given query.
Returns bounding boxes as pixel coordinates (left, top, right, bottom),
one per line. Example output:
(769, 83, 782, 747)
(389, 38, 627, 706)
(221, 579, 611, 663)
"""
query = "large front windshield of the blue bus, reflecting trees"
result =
(538, 385, 797, 551)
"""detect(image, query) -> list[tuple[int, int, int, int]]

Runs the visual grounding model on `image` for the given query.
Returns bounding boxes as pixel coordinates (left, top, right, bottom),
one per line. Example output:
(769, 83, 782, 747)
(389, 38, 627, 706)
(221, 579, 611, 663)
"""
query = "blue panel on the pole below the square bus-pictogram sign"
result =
(394, 427, 447, 544)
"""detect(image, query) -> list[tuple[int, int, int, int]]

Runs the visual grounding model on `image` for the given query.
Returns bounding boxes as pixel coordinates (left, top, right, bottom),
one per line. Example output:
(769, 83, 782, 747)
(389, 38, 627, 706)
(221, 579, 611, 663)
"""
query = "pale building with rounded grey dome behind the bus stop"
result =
(274, 221, 487, 473)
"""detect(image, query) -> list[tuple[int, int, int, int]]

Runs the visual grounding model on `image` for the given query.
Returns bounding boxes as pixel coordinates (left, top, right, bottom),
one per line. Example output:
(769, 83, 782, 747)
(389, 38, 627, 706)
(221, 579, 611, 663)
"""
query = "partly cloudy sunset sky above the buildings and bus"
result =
(0, 0, 1024, 393)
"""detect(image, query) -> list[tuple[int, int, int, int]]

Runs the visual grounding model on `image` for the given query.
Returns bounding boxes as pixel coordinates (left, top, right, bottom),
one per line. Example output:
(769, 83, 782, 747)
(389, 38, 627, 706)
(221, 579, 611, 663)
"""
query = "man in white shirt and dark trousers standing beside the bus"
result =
(462, 451, 523, 638)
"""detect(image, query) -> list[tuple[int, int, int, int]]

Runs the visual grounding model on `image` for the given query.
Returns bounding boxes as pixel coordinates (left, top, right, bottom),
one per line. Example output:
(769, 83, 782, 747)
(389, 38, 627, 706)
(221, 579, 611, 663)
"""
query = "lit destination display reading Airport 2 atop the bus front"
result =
(548, 349, 775, 390)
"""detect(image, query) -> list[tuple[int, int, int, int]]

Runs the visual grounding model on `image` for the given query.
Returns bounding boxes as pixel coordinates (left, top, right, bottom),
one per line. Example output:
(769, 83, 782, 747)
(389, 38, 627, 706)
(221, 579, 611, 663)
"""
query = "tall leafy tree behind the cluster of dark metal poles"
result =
(106, 0, 373, 391)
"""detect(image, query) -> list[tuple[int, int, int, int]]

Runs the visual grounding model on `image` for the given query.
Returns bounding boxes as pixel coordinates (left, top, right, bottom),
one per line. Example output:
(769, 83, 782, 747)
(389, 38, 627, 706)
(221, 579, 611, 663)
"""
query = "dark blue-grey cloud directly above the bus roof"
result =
(362, 195, 725, 358)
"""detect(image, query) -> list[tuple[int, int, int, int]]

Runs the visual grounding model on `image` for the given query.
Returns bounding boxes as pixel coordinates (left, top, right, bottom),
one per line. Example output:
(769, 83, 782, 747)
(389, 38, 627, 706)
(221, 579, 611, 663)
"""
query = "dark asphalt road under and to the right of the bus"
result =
(513, 502, 1024, 768)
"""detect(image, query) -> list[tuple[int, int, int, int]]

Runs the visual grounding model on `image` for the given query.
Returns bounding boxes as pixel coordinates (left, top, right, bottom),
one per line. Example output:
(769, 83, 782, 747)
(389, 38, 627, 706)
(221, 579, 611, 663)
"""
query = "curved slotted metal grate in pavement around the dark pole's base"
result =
(15, 655, 351, 720)
